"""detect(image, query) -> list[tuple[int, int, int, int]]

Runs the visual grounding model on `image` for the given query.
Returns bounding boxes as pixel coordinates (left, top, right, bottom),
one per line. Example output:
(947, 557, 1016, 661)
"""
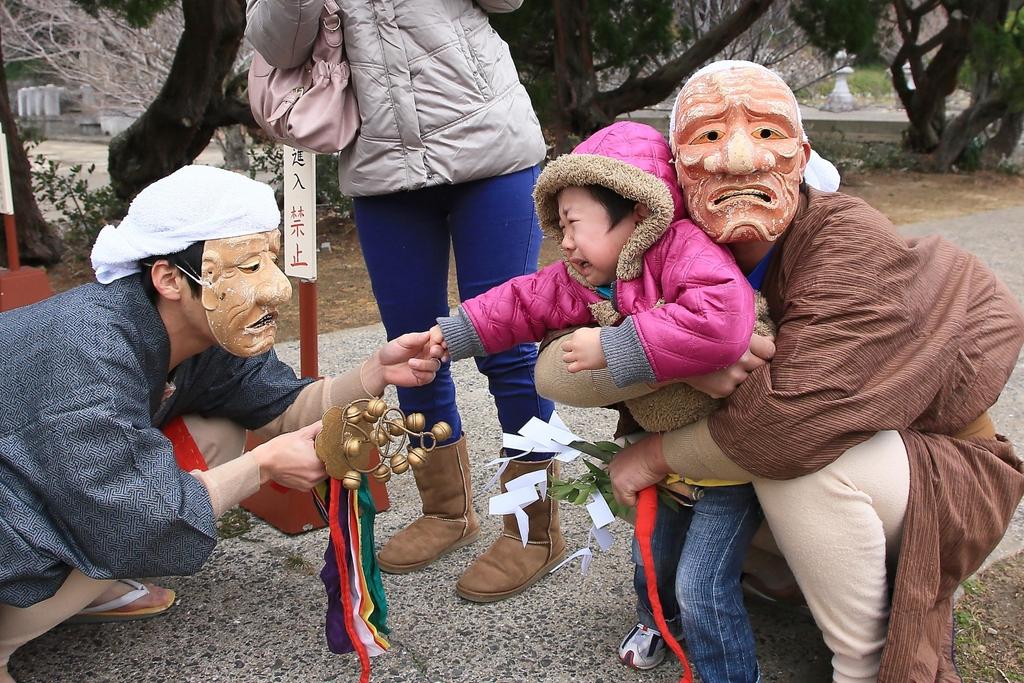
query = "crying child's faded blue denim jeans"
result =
(633, 484, 761, 683)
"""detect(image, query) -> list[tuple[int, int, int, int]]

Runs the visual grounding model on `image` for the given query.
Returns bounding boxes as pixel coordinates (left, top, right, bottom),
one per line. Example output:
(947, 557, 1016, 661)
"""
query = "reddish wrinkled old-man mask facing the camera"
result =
(672, 65, 810, 243)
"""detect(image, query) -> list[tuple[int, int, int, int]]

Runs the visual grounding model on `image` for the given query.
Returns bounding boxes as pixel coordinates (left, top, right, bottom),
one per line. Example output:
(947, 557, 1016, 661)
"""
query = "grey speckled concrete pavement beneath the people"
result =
(11, 207, 1024, 683)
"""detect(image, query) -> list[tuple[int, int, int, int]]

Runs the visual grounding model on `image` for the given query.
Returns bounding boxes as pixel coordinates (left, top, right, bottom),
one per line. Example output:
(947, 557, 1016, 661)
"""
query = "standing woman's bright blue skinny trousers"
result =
(353, 167, 554, 460)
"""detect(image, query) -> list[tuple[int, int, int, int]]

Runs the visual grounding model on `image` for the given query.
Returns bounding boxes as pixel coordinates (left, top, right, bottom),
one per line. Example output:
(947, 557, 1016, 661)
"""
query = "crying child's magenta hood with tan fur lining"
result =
(534, 121, 684, 289)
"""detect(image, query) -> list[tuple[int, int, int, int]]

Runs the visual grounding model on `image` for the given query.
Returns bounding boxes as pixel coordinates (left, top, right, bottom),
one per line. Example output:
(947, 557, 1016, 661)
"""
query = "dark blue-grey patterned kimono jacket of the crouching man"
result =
(0, 275, 306, 607)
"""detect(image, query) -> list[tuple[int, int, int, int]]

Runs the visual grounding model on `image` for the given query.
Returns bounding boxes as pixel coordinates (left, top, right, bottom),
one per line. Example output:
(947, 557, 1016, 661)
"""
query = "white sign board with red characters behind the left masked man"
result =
(283, 144, 316, 281)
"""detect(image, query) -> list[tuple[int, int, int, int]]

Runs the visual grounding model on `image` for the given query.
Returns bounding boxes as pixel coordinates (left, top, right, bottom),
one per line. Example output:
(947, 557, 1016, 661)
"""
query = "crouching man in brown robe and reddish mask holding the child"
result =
(538, 61, 1024, 683)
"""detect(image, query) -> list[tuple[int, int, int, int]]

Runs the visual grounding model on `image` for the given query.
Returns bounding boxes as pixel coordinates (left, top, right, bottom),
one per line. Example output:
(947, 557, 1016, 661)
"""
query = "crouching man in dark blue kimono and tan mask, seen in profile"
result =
(0, 166, 439, 681)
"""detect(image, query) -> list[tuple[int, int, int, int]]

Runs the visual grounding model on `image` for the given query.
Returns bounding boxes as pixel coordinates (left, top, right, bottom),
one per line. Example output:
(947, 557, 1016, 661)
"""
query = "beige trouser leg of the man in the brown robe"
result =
(754, 431, 910, 683)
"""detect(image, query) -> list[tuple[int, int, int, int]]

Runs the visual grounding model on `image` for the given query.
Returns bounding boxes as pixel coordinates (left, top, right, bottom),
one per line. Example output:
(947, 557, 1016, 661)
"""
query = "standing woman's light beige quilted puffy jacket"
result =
(246, 0, 545, 197)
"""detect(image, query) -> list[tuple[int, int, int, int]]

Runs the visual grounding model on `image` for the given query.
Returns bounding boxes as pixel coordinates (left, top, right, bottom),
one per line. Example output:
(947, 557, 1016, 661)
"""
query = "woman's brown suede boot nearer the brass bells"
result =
(377, 436, 480, 573)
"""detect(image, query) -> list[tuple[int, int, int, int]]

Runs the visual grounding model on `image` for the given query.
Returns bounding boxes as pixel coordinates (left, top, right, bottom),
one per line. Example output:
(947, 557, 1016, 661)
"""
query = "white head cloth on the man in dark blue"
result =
(92, 166, 281, 285)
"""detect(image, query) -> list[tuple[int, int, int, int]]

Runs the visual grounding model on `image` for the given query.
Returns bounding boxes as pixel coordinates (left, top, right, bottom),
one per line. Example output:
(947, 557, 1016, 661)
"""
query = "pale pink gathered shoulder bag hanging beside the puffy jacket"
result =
(249, 0, 359, 154)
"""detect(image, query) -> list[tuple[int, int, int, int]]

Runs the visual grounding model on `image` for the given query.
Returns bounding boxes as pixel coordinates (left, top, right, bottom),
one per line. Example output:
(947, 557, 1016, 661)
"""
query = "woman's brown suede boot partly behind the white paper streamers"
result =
(456, 460, 565, 602)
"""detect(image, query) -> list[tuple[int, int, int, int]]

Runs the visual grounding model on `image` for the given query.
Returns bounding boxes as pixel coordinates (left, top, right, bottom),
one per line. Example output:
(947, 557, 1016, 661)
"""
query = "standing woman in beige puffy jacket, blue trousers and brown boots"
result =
(246, 0, 564, 602)
